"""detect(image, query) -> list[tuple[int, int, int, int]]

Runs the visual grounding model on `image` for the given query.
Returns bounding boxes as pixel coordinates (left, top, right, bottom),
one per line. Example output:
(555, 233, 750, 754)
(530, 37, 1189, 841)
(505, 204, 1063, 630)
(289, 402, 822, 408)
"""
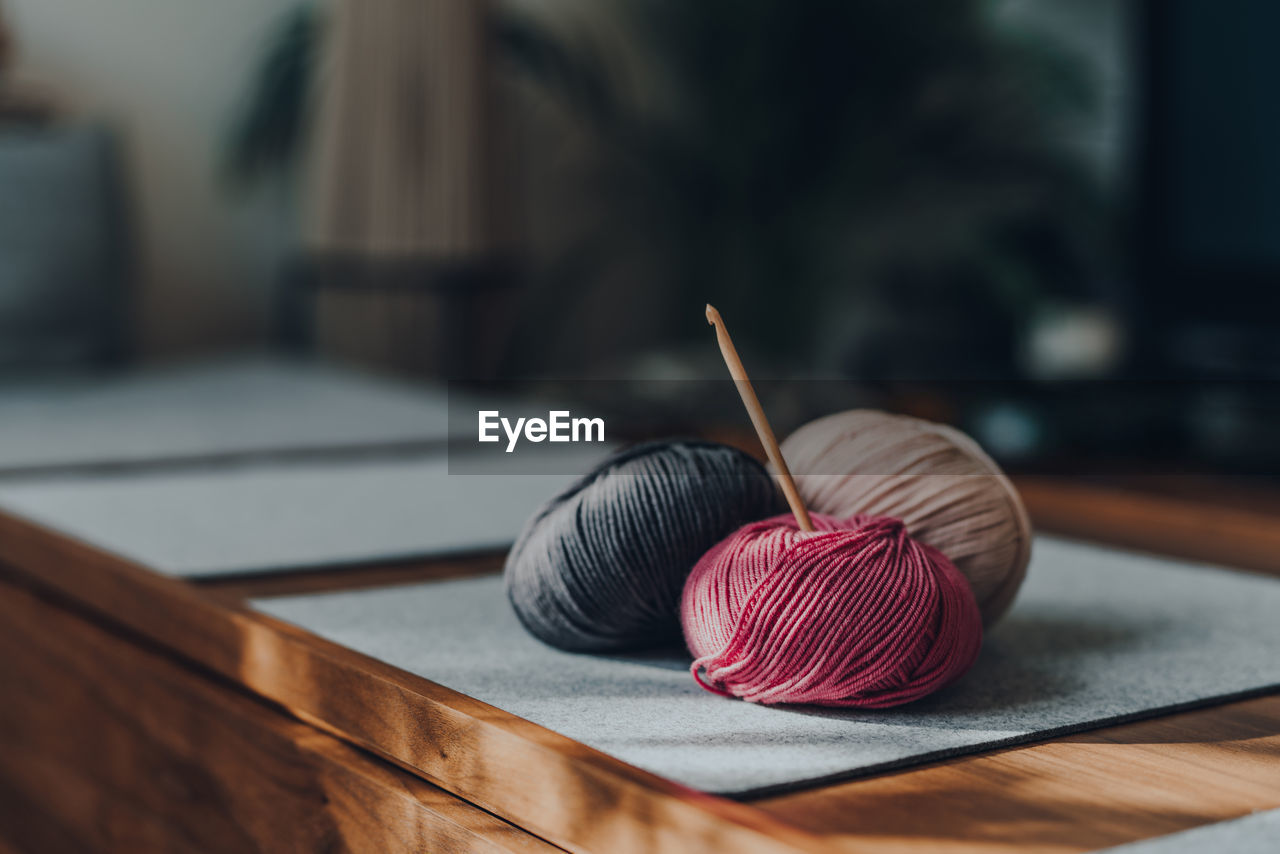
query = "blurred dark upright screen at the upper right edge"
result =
(1138, 0, 1280, 376)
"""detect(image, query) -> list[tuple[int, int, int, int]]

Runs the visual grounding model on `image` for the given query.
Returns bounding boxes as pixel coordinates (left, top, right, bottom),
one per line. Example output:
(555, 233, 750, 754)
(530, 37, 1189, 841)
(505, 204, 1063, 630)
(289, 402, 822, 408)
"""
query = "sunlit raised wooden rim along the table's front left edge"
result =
(0, 512, 823, 854)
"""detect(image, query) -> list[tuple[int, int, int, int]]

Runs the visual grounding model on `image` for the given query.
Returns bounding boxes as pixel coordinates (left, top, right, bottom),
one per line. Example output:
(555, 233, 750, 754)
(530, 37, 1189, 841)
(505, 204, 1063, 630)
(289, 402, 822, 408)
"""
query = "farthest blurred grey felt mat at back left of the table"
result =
(0, 357, 449, 474)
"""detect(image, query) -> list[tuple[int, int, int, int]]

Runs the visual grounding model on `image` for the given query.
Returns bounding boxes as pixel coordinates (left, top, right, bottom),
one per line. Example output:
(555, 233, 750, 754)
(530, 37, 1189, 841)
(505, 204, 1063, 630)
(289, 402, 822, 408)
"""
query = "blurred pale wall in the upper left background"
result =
(0, 0, 312, 356)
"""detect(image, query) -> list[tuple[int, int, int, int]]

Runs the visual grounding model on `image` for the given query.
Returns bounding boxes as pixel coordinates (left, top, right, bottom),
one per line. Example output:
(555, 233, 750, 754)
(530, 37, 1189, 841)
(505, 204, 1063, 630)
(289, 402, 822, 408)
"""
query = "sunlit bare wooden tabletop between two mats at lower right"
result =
(756, 697, 1280, 854)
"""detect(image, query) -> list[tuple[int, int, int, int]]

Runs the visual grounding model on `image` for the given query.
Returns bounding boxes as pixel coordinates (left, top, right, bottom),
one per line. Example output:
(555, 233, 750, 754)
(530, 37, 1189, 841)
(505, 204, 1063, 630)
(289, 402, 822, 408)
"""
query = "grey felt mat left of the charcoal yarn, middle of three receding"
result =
(0, 451, 591, 577)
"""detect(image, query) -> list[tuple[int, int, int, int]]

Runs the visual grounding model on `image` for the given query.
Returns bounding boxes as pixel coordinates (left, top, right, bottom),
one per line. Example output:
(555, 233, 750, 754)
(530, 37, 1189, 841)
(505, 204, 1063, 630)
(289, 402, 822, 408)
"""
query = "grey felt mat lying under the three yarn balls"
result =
(255, 538, 1280, 795)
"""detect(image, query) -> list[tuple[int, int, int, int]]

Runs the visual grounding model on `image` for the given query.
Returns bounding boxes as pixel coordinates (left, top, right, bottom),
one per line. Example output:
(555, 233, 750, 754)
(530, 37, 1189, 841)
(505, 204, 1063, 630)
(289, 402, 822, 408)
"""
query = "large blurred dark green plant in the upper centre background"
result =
(500, 0, 1103, 363)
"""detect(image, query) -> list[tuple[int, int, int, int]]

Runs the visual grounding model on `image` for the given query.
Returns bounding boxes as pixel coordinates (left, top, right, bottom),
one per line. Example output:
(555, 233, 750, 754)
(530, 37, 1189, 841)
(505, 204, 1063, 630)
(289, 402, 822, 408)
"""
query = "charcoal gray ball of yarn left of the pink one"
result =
(504, 440, 786, 652)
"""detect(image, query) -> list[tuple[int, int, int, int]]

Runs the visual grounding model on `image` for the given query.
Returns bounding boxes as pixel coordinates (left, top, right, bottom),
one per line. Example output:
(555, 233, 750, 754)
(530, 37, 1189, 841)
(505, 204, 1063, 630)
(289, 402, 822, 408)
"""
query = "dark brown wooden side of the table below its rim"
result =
(0, 573, 559, 854)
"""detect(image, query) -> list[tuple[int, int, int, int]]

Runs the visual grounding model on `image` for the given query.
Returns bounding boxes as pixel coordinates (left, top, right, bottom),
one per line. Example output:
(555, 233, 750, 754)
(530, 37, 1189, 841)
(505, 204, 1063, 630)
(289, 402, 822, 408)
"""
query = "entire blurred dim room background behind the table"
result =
(0, 0, 1280, 475)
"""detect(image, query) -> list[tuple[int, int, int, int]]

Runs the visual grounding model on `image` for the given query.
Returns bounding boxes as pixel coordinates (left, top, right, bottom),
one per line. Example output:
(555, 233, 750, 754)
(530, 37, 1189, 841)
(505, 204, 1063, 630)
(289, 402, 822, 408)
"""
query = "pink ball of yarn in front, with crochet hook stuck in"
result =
(680, 513, 982, 708)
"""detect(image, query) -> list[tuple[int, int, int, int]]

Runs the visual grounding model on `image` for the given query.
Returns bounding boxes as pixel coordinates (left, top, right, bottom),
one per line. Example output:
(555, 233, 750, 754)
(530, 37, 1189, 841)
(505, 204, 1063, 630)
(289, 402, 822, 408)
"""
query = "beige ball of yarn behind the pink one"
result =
(782, 410, 1032, 626)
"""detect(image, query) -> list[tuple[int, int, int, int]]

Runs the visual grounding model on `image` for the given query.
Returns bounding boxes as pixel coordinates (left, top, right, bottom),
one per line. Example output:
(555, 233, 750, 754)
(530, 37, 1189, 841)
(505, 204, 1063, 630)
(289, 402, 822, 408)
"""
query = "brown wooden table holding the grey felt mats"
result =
(0, 480, 1280, 854)
